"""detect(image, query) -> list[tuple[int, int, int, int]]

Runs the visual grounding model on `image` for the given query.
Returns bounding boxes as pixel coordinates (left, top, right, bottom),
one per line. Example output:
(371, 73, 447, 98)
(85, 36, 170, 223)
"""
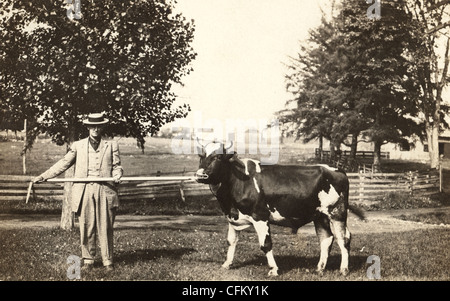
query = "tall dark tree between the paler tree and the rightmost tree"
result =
(339, 0, 422, 170)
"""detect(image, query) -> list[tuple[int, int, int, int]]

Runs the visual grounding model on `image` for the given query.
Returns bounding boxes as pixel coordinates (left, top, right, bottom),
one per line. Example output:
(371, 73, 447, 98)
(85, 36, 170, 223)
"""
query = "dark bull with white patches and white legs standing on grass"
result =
(196, 142, 364, 276)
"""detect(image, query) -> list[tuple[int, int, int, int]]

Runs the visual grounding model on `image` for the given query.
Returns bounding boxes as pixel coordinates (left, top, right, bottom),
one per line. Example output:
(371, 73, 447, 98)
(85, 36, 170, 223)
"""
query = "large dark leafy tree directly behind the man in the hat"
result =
(0, 0, 196, 228)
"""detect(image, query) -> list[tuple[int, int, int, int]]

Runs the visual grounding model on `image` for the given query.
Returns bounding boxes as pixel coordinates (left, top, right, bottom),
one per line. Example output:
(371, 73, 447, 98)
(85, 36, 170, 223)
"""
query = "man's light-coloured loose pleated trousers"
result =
(79, 182, 116, 266)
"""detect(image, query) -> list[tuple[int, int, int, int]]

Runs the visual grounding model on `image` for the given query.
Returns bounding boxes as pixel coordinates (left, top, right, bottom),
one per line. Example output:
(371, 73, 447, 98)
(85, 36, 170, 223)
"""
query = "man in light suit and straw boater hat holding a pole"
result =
(33, 113, 123, 270)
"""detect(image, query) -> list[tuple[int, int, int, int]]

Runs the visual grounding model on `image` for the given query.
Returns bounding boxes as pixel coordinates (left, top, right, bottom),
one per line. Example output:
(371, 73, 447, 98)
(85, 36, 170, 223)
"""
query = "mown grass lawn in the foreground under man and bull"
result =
(0, 223, 450, 281)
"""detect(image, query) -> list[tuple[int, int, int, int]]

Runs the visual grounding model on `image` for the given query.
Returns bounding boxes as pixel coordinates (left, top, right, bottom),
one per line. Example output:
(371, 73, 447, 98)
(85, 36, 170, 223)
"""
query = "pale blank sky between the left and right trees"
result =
(169, 0, 326, 127)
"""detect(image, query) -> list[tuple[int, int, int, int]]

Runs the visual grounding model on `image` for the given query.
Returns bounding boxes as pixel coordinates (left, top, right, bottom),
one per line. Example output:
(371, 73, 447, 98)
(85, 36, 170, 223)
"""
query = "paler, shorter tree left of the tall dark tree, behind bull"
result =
(283, 13, 364, 161)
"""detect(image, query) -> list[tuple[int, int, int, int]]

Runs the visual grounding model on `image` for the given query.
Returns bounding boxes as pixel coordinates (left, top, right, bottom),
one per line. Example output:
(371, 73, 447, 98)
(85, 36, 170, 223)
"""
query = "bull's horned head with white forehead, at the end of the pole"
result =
(196, 139, 235, 185)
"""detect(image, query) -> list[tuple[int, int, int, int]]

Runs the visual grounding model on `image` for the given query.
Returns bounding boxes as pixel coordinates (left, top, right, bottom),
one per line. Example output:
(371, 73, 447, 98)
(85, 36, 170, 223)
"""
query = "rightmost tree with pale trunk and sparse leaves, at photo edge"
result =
(406, 1, 450, 168)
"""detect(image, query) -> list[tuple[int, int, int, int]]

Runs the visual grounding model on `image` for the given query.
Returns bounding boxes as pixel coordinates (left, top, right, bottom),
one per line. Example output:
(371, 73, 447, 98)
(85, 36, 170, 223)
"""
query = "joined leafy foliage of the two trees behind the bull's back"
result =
(285, 0, 423, 163)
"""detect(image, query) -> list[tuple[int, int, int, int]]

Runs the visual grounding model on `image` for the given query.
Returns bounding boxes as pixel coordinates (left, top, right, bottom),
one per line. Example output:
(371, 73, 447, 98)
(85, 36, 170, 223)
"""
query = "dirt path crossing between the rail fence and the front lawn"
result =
(0, 207, 450, 234)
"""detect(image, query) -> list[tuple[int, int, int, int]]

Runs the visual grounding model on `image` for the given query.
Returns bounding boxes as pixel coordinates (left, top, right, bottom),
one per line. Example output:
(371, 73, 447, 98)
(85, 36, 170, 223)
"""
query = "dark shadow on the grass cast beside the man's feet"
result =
(115, 248, 197, 264)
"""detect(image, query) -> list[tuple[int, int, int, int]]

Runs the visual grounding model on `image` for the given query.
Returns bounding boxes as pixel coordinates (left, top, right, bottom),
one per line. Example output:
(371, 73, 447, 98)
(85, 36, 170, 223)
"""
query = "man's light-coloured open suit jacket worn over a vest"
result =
(41, 138, 123, 212)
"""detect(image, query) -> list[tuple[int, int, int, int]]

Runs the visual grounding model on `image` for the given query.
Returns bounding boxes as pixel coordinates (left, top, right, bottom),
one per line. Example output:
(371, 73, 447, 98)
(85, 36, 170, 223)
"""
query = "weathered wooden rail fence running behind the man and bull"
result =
(0, 171, 442, 202)
